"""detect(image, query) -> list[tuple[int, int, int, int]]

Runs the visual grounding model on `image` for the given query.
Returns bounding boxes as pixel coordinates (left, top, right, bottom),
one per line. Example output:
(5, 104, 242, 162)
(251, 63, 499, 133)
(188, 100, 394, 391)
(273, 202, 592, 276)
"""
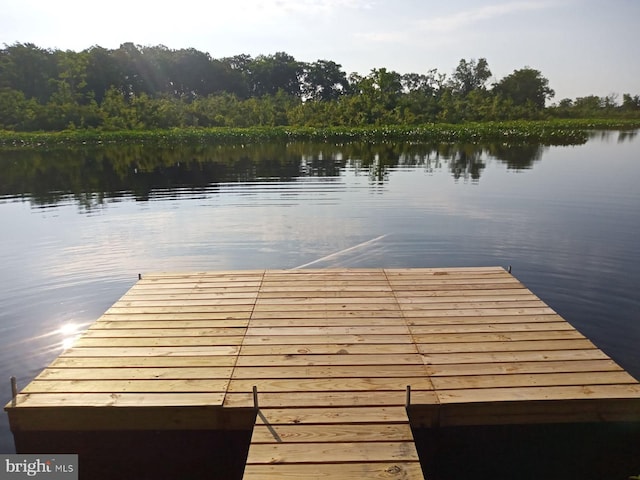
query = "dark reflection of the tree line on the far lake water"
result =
(0, 143, 545, 211)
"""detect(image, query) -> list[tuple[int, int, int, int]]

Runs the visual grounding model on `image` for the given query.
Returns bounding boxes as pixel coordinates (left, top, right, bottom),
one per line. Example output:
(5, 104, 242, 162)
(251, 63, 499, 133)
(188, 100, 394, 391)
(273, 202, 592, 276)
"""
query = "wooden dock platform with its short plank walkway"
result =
(5, 267, 640, 480)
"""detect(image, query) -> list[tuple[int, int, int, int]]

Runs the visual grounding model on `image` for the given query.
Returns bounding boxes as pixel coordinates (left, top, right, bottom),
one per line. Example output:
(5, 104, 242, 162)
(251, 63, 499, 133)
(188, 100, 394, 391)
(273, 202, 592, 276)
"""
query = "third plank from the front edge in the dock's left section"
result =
(36, 366, 233, 380)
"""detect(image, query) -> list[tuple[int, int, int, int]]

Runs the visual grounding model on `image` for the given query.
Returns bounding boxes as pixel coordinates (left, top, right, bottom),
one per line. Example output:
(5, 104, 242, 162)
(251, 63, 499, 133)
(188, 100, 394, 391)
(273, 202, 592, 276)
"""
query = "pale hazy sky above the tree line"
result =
(0, 0, 640, 102)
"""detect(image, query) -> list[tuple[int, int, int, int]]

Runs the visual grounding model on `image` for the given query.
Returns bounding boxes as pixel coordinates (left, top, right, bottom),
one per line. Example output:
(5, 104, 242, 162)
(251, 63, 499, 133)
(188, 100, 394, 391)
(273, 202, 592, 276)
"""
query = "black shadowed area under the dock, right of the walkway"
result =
(413, 422, 640, 480)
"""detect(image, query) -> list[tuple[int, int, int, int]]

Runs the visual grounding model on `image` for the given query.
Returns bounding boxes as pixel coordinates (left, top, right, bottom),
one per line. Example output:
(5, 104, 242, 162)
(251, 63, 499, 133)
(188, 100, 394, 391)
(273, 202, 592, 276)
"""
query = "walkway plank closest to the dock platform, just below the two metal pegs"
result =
(256, 405, 407, 425)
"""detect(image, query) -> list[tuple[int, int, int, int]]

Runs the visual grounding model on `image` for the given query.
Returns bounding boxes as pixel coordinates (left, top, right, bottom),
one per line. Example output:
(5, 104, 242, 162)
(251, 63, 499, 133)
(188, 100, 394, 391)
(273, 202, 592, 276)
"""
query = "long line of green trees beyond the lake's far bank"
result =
(0, 43, 640, 131)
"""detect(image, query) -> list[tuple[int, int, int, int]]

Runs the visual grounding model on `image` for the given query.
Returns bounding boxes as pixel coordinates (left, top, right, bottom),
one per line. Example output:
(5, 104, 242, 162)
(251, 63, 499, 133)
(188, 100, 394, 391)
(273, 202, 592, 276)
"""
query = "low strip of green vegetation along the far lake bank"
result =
(0, 119, 640, 149)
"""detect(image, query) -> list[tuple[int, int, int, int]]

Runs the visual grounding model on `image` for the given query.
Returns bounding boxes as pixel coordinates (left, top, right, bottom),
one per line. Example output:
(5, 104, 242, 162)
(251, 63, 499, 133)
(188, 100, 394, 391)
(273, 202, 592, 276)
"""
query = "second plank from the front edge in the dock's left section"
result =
(22, 379, 229, 394)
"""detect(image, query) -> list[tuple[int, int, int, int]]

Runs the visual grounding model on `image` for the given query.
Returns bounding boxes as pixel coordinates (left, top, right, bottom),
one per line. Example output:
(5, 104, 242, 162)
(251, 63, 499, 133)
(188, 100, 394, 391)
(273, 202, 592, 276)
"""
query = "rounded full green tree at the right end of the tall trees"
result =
(493, 67, 555, 109)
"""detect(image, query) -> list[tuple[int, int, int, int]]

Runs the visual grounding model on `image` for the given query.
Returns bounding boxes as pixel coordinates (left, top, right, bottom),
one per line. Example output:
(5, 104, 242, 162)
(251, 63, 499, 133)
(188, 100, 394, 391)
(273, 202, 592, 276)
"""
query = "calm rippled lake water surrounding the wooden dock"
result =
(0, 132, 640, 453)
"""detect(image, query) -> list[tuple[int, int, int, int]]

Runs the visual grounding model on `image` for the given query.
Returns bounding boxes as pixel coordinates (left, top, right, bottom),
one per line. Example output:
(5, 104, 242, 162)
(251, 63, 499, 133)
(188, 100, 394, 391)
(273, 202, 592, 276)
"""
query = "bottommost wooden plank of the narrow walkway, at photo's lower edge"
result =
(242, 461, 424, 480)
